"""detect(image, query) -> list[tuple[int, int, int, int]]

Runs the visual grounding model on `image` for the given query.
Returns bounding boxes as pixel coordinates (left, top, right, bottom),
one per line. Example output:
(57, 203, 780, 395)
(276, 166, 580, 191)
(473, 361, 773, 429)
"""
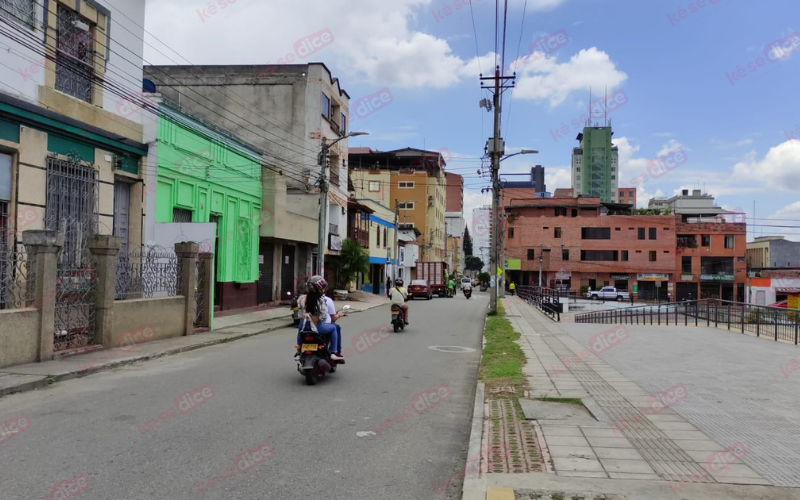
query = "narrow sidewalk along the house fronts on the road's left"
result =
(0, 301, 383, 396)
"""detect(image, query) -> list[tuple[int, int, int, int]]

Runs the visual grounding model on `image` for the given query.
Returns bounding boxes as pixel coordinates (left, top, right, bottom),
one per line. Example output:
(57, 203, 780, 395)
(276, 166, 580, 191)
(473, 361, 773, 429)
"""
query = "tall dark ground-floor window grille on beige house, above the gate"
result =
(45, 154, 98, 266)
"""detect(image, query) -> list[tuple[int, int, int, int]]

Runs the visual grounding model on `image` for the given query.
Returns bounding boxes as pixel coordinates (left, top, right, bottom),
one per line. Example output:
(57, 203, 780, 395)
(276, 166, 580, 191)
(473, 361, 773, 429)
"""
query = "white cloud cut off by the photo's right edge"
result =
(733, 140, 800, 192)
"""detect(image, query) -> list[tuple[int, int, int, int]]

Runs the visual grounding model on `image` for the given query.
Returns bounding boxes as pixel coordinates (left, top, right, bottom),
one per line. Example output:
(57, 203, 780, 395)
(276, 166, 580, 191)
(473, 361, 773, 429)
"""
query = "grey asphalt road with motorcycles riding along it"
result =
(0, 293, 488, 500)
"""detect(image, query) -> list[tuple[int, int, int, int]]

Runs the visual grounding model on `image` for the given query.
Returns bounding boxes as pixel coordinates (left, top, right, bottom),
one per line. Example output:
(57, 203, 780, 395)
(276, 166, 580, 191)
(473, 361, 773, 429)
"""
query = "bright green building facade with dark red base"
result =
(148, 104, 263, 310)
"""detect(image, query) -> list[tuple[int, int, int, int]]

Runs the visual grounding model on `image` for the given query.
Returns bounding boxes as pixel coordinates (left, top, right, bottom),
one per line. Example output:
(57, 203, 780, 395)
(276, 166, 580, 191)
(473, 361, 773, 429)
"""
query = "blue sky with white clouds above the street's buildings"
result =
(145, 0, 800, 240)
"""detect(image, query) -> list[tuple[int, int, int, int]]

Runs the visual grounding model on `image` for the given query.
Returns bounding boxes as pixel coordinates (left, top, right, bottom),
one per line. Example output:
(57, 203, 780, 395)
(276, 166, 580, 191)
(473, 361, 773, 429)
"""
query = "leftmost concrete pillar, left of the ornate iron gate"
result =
(22, 230, 64, 361)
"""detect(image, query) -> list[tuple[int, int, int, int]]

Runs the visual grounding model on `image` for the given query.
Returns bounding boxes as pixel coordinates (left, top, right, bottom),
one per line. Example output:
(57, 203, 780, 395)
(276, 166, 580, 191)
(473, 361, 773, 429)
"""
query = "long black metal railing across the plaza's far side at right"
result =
(575, 299, 800, 344)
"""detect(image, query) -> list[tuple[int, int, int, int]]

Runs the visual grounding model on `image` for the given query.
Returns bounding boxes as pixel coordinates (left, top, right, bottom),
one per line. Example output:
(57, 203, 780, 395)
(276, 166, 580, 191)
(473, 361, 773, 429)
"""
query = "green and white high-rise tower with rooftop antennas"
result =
(572, 126, 619, 203)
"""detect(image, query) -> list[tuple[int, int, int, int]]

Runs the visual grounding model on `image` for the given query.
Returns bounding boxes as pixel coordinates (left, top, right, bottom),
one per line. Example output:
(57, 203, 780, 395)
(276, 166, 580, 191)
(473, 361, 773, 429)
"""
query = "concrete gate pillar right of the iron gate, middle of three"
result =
(86, 234, 121, 349)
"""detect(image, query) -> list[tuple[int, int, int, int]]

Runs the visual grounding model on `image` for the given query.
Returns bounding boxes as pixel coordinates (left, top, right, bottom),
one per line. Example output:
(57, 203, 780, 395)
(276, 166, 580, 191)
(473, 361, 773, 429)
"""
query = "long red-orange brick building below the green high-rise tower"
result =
(503, 190, 745, 300)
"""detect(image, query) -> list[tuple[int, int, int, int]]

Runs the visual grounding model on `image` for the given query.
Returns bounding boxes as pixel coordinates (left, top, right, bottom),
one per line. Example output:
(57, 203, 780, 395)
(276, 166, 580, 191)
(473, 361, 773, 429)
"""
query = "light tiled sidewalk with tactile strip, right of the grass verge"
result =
(462, 298, 800, 500)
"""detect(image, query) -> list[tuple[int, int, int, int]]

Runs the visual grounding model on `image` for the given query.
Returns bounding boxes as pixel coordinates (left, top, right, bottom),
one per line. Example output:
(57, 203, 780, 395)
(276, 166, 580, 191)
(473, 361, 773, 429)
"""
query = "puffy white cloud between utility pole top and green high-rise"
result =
(513, 47, 628, 107)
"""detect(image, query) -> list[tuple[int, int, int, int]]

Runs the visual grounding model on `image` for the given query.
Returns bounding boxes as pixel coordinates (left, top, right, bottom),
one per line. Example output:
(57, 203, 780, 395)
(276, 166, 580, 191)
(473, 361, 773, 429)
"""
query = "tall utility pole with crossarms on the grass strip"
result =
(480, 66, 514, 314)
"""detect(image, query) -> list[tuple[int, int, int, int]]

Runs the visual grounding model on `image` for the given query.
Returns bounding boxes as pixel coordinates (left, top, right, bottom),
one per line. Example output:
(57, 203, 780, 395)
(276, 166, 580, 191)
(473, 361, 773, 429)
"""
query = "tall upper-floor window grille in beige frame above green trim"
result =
(56, 4, 94, 102)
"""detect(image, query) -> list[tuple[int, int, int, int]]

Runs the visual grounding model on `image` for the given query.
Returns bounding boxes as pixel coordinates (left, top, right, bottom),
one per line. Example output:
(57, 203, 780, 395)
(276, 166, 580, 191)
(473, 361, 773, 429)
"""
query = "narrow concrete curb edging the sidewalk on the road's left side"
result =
(0, 304, 384, 397)
